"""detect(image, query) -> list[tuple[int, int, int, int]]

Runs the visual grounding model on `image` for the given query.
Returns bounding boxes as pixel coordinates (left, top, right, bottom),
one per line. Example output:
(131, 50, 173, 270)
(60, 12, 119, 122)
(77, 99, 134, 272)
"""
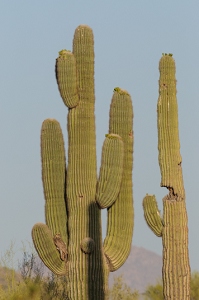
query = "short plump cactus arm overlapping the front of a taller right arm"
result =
(96, 134, 124, 208)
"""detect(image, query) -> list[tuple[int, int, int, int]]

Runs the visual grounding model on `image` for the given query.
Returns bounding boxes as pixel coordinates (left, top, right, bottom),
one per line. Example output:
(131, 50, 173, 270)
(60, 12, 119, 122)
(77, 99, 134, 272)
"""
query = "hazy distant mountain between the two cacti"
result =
(109, 246, 162, 292)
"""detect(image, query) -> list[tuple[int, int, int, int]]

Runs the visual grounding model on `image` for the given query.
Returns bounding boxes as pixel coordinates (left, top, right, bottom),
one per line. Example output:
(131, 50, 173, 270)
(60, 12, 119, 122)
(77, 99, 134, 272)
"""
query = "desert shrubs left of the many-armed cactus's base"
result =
(0, 243, 67, 300)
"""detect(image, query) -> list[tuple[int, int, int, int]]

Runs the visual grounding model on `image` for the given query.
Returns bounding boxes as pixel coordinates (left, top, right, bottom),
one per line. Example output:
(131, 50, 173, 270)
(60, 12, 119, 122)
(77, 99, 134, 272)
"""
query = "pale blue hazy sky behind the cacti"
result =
(0, 0, 199, 270)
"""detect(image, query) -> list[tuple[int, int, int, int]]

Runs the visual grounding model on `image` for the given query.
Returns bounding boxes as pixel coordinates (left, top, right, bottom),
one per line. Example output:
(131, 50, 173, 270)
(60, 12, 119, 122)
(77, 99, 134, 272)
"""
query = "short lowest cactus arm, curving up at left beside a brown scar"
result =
(32, 223, 67, 275)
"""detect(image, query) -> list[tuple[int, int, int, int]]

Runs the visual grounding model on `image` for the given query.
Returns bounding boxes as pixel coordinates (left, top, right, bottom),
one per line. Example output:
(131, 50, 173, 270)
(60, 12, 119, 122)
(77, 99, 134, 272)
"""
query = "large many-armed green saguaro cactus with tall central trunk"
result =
(32, 25, 133, 300)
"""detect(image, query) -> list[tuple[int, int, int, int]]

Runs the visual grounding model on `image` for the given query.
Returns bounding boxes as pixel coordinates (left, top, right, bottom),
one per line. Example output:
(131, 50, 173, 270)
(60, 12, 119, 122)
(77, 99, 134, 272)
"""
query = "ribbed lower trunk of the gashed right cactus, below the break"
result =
(162, 199, 190, 300)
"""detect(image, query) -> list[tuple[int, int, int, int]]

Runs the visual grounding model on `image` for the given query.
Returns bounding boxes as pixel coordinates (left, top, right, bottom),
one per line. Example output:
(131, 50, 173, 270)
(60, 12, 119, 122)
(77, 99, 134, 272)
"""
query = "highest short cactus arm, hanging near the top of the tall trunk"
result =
(55, 50, 79, 108)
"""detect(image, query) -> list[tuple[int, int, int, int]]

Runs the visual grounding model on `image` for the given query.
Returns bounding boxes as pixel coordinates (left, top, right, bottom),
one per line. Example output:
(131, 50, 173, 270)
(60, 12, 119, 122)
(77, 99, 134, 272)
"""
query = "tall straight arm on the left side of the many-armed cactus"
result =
(41, 119, 68, 243)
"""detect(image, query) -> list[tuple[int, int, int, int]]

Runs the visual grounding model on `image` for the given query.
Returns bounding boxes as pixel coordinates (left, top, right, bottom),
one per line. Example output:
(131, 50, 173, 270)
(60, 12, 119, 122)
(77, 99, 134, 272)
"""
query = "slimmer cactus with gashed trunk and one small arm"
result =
(143, 54, 190, 300)
